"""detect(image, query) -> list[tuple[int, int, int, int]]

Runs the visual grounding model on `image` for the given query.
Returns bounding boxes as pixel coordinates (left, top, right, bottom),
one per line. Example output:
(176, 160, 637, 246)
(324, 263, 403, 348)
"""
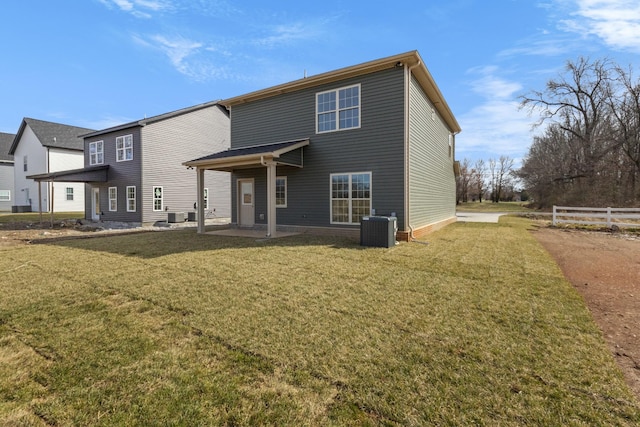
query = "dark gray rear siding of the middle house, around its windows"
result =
(84, 126, 142, 222)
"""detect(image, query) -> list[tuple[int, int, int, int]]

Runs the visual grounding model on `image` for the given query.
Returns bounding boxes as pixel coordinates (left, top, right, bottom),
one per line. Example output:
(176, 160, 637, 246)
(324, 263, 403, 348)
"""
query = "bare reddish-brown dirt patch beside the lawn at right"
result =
(533, 227, 640, 400)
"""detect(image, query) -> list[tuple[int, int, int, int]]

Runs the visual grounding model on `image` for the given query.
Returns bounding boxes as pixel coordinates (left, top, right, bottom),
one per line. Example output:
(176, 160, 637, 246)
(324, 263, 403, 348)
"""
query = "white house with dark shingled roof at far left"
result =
(9, 118, 92, 212)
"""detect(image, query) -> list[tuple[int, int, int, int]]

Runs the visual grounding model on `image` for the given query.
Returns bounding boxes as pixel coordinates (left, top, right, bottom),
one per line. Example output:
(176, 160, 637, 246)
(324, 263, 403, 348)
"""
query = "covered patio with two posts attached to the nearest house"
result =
(183, 138, 309, 238)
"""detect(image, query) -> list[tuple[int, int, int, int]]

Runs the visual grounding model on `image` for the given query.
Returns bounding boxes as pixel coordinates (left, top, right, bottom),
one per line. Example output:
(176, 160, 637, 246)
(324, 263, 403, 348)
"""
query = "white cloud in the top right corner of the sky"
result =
(561, 0, 640, 52)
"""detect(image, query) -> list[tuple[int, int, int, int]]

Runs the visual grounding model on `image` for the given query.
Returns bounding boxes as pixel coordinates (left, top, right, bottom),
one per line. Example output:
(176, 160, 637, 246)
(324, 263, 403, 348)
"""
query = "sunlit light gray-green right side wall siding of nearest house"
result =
(409, 74, 455, 228)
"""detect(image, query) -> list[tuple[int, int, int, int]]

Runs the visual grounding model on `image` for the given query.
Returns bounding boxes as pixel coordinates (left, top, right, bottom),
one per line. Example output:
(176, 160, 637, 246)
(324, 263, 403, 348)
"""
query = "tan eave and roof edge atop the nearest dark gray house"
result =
(220, 50, 461, 133)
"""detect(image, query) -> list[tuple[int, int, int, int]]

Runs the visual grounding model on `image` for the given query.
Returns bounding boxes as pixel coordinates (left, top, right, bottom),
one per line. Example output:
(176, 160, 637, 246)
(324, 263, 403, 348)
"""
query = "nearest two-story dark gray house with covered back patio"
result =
(185, 51, 460, 240)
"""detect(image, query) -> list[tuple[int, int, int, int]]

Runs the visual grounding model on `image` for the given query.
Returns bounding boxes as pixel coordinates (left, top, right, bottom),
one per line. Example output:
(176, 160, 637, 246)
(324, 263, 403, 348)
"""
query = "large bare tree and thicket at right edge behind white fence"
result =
(520, 58, 640, 205)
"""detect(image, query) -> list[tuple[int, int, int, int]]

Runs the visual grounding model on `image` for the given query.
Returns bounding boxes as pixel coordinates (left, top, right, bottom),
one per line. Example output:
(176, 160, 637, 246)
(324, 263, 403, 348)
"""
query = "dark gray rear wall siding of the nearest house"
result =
(231, 68, 404, 231)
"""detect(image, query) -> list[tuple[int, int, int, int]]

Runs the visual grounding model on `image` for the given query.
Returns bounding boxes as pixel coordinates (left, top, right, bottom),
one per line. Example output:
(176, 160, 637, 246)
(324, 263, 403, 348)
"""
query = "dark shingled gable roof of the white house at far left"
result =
(9, 117, 93, 154)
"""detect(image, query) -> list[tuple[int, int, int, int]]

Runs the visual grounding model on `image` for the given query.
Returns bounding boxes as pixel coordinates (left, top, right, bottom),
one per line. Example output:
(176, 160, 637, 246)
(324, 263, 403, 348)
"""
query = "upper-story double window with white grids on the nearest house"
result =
(316, 84, 360, 133)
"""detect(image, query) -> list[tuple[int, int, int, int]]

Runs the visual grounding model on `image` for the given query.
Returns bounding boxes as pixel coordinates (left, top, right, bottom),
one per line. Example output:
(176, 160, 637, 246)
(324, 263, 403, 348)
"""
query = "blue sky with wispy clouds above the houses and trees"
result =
(0, 0, 640, 166)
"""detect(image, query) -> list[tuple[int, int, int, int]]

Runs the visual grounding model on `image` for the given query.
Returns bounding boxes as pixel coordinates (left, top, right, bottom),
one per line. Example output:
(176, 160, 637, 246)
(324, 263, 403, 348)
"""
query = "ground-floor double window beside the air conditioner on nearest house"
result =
(331, 172, 371, 224)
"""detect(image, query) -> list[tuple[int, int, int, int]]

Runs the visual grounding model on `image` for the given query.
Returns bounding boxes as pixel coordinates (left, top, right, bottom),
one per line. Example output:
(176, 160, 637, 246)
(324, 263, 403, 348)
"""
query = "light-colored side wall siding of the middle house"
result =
(139, 105, 231, 222)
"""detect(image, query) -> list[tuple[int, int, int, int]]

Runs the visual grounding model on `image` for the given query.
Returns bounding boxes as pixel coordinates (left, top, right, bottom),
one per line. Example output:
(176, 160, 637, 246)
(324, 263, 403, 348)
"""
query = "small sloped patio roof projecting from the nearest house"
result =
(183, 138, 309, 171)
